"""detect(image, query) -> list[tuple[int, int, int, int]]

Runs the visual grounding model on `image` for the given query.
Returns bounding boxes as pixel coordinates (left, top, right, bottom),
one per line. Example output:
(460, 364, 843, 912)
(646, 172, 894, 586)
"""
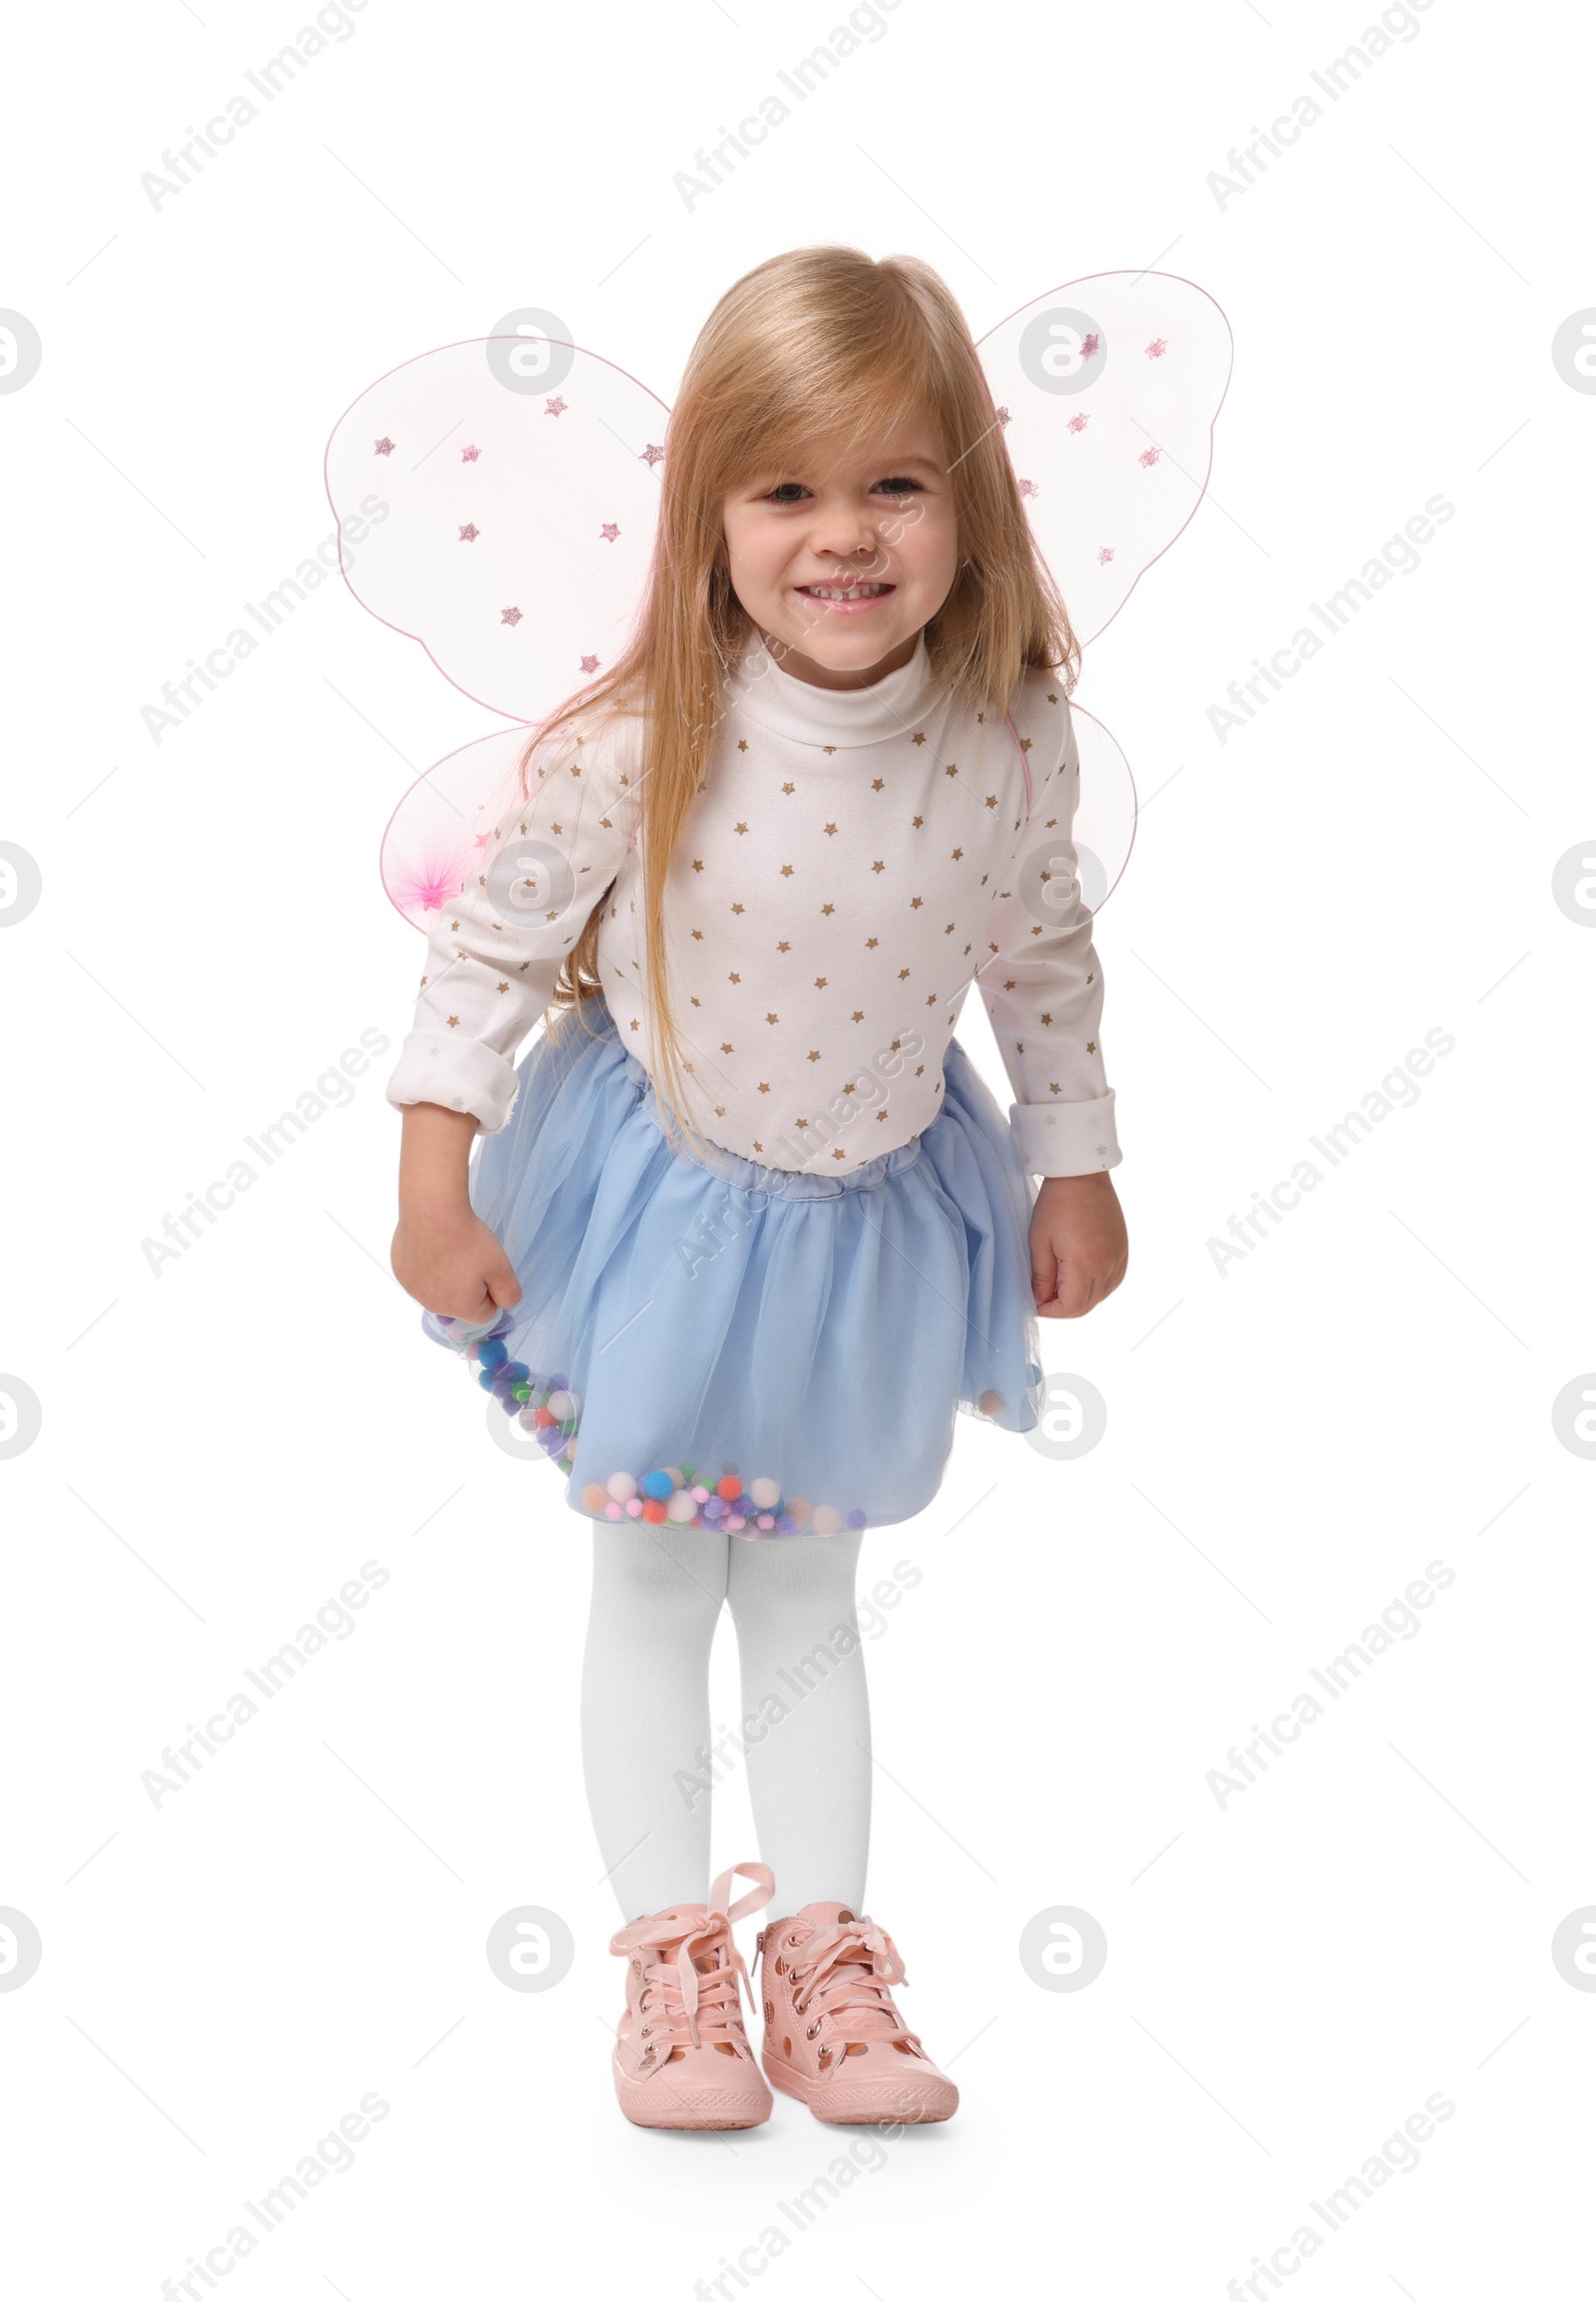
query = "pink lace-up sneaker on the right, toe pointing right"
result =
(758, 1901, 958, 2127)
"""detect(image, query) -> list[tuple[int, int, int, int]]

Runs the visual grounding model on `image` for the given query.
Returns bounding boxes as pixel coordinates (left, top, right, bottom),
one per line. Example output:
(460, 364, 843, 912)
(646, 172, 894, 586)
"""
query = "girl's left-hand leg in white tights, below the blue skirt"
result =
(583, 1519, 732, 1920)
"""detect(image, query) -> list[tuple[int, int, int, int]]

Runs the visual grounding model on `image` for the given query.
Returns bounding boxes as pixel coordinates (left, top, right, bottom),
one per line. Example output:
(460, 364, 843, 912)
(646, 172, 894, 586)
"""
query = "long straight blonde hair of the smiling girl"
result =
(523, 246, 1080, 1144)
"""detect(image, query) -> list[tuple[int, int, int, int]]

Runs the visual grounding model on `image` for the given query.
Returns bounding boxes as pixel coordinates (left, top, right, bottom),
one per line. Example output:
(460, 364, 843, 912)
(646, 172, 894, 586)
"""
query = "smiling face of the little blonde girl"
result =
(721, 417, 958, 688)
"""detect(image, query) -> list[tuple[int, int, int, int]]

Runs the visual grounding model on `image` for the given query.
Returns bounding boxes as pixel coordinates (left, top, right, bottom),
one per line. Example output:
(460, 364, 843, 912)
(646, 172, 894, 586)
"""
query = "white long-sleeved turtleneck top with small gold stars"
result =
(387, 637, 1121, 1174)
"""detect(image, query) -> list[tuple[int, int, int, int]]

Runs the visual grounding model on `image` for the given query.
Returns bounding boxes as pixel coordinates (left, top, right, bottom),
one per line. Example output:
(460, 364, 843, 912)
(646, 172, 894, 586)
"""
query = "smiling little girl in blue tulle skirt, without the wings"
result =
(389, 248, 1126, 2127)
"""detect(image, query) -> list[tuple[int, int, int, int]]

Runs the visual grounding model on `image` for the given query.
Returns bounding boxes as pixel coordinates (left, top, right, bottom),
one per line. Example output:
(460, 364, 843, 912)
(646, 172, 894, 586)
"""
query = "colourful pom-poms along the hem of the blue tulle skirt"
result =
(435, 1313, 868, 1542)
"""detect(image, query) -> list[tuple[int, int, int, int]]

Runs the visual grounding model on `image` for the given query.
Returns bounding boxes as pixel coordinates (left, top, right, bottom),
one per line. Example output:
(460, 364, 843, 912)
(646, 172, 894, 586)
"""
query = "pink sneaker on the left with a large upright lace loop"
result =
(610, 1862, 776, 2127)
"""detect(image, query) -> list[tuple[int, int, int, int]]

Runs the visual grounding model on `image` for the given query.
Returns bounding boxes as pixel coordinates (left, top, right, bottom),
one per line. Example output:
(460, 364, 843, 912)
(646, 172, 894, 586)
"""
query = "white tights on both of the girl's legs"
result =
(583, 1519, 871, 1920)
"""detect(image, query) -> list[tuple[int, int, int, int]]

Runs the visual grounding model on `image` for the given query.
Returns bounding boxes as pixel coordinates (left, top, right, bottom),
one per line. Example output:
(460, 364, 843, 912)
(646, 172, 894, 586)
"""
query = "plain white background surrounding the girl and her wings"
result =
(0, 0, 1596, 2302)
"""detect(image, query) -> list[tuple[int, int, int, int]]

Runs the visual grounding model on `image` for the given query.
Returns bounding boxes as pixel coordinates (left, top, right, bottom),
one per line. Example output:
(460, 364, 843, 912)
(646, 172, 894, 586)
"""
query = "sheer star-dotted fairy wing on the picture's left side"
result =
(327, 331, 665, 928)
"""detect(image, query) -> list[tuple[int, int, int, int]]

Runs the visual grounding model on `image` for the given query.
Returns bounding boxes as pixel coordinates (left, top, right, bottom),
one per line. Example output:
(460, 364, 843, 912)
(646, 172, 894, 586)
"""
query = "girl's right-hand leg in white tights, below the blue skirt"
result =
(725, 1533, 871, 1918)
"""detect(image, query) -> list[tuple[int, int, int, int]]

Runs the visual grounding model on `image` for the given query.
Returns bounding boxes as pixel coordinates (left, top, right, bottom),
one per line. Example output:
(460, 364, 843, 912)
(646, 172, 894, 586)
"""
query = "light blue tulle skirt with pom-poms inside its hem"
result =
(424, 1001, 1041, 1538)
